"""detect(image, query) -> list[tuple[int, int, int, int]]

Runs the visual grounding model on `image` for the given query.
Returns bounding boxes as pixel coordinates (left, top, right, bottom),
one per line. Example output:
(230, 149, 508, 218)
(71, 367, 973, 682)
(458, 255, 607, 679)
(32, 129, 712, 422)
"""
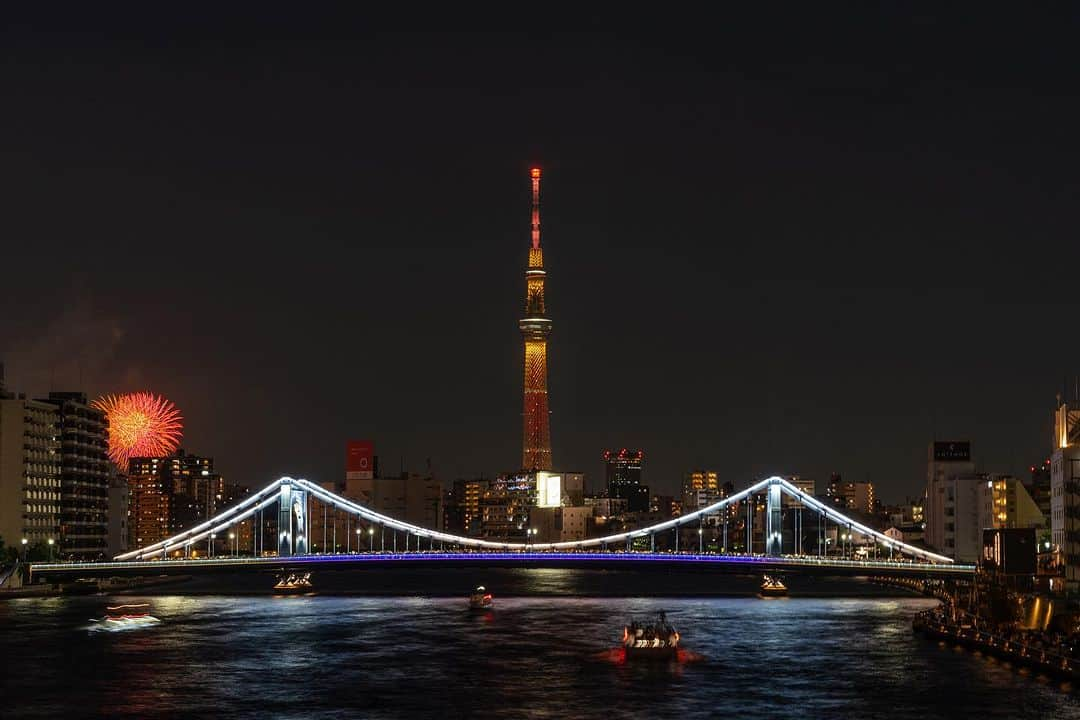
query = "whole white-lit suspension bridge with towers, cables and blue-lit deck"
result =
(30, 476, 974, 578)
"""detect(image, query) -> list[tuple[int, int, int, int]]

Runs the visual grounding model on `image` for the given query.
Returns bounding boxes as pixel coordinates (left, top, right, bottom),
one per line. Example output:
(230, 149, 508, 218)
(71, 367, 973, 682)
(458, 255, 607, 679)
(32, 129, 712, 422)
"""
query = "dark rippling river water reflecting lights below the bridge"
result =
(0, 571, 1080, 720)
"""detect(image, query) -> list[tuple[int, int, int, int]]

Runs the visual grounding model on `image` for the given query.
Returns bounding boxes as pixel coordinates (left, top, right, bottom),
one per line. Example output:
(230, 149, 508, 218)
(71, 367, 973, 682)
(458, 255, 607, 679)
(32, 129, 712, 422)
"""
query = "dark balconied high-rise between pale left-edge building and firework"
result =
(40, 392, 111, 560)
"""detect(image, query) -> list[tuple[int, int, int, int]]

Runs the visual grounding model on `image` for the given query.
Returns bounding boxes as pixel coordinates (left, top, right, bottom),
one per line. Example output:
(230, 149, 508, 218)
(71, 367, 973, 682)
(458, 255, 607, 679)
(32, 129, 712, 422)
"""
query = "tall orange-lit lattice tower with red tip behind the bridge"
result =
(517, 167, 551, 470)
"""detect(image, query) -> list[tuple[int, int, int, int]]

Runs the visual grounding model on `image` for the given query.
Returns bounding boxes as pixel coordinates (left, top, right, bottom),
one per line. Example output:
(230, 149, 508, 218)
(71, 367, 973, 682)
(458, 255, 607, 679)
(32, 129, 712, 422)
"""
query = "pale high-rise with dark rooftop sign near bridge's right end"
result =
(923, 441, 987, 562)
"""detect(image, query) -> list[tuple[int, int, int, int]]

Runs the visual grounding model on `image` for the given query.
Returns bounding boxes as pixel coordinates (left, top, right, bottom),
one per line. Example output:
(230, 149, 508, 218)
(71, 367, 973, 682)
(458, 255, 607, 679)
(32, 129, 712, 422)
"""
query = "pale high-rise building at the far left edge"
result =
(0, 395, 62, 552)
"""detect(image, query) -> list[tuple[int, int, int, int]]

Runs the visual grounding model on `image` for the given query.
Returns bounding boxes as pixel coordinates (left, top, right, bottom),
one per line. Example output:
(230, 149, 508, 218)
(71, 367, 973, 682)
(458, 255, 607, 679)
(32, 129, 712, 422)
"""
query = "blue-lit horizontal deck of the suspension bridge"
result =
(30, 552, 975, 578)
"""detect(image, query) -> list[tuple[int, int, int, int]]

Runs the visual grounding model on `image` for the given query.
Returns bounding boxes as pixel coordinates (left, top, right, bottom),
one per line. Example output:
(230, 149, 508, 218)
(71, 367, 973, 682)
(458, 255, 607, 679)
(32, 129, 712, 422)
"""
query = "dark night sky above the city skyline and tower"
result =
(0, 3, 1080, 500)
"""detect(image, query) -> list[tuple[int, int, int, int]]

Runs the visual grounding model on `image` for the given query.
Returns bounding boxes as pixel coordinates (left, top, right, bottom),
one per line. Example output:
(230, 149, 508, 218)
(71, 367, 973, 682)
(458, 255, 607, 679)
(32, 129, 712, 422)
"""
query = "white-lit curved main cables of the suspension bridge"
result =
(114, 476, 953, 563)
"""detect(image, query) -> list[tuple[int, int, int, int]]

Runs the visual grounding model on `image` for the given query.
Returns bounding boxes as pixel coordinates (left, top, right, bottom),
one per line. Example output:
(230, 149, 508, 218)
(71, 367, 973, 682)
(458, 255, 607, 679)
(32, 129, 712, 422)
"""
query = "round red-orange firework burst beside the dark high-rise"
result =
(93, 393, 184, 471)
